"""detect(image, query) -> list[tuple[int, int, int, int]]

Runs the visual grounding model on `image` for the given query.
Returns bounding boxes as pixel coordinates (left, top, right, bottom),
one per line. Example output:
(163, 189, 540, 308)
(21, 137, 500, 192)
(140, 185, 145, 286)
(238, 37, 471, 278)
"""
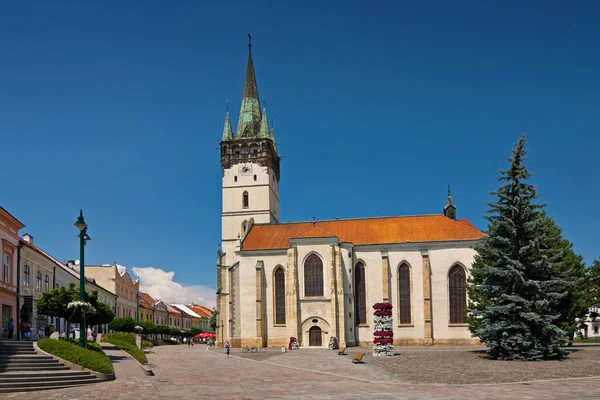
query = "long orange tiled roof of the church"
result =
(242, 215, 484, 250)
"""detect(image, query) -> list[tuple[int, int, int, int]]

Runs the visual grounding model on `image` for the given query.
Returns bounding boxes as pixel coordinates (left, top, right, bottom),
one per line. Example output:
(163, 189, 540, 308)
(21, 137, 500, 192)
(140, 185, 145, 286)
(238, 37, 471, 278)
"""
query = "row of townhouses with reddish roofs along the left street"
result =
(0, 207, 212, 339)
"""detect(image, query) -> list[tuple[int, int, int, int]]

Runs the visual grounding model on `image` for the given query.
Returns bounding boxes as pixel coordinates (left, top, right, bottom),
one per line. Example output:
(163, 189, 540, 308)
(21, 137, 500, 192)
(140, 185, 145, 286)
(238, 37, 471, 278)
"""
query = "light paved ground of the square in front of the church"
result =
(6, 345, 600, 400)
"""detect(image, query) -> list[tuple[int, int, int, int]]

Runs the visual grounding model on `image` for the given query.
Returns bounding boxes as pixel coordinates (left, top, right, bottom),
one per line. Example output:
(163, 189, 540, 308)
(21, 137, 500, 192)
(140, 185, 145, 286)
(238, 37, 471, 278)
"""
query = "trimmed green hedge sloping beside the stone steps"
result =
(37, 339, 114, 374)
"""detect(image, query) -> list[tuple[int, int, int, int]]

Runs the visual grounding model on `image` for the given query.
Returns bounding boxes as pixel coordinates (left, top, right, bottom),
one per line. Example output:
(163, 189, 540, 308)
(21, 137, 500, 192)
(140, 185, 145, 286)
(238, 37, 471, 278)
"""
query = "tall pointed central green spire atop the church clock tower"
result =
(237, 34, 261, 138)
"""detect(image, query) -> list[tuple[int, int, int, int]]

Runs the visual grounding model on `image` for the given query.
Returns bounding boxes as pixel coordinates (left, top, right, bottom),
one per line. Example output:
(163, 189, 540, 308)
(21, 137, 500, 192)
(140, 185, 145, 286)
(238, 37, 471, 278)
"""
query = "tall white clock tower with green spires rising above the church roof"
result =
(221, 42, 280, 266)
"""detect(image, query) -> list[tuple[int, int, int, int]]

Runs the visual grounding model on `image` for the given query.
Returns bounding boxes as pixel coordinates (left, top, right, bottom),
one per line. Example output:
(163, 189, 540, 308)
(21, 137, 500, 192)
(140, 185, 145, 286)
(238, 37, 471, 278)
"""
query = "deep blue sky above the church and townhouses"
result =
(0, 1, 600, 302)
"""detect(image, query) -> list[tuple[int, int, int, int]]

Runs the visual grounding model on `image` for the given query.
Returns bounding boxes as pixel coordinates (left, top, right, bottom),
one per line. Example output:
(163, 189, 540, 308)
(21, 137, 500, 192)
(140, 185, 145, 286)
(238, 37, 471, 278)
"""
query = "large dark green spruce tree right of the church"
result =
(468, 136, 569, 360)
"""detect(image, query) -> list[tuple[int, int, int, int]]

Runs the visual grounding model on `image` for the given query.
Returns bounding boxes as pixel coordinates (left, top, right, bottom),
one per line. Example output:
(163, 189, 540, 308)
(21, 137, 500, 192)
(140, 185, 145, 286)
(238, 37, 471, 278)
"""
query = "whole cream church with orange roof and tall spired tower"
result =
(217, 41, 484, 347)
